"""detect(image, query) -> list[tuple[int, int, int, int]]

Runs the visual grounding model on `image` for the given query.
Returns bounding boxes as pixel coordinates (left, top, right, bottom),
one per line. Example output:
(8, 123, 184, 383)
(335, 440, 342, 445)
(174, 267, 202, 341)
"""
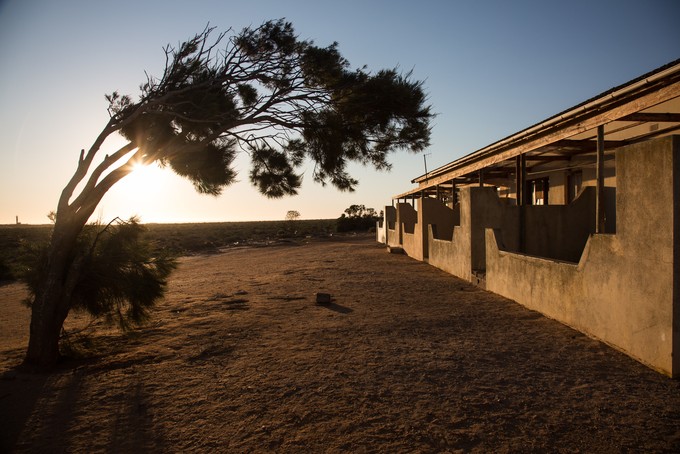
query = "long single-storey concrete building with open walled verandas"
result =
(377, 60, 680, 377)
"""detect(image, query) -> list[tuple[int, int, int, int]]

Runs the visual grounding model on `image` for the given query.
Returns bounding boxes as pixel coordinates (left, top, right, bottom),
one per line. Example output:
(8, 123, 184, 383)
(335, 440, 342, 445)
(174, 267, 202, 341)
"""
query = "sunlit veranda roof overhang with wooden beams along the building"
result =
(393, 60, 680, 199)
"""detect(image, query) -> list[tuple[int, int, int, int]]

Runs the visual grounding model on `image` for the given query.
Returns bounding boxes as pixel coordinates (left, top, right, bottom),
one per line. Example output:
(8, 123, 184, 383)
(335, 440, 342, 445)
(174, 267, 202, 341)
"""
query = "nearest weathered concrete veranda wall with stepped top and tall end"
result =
(486, 136, 680, 376)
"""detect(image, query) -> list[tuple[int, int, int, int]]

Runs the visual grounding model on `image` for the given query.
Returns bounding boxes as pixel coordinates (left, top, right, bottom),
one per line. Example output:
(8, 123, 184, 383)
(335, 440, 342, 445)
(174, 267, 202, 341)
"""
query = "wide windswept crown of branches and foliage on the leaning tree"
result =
(91, 20, 432, 207)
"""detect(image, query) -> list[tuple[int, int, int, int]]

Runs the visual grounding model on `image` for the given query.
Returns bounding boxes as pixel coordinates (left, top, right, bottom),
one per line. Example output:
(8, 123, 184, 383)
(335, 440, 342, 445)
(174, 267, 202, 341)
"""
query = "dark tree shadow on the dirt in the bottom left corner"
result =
(0, 336, 168, 452)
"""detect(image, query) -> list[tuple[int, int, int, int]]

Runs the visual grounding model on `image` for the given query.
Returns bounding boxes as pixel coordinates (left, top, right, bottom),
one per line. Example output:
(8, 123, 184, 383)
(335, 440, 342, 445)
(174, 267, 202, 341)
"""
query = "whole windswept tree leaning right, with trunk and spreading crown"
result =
(24, 20, 432, 368)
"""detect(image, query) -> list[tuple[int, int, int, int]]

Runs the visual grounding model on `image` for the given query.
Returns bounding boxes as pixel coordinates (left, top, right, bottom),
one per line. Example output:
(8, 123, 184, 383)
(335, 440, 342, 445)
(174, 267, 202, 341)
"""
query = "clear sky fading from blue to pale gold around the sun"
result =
(0, 0, 680, 224)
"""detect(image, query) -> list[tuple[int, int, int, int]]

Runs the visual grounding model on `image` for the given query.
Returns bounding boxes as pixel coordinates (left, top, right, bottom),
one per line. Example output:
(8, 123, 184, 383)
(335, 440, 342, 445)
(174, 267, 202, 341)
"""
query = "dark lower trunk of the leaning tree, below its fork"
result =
(24, 217, 82, 370)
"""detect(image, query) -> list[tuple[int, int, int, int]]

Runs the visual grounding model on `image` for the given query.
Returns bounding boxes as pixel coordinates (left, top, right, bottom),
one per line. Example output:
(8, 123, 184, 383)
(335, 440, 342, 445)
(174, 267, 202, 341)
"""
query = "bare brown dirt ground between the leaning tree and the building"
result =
(0, 236, 680, 453)
